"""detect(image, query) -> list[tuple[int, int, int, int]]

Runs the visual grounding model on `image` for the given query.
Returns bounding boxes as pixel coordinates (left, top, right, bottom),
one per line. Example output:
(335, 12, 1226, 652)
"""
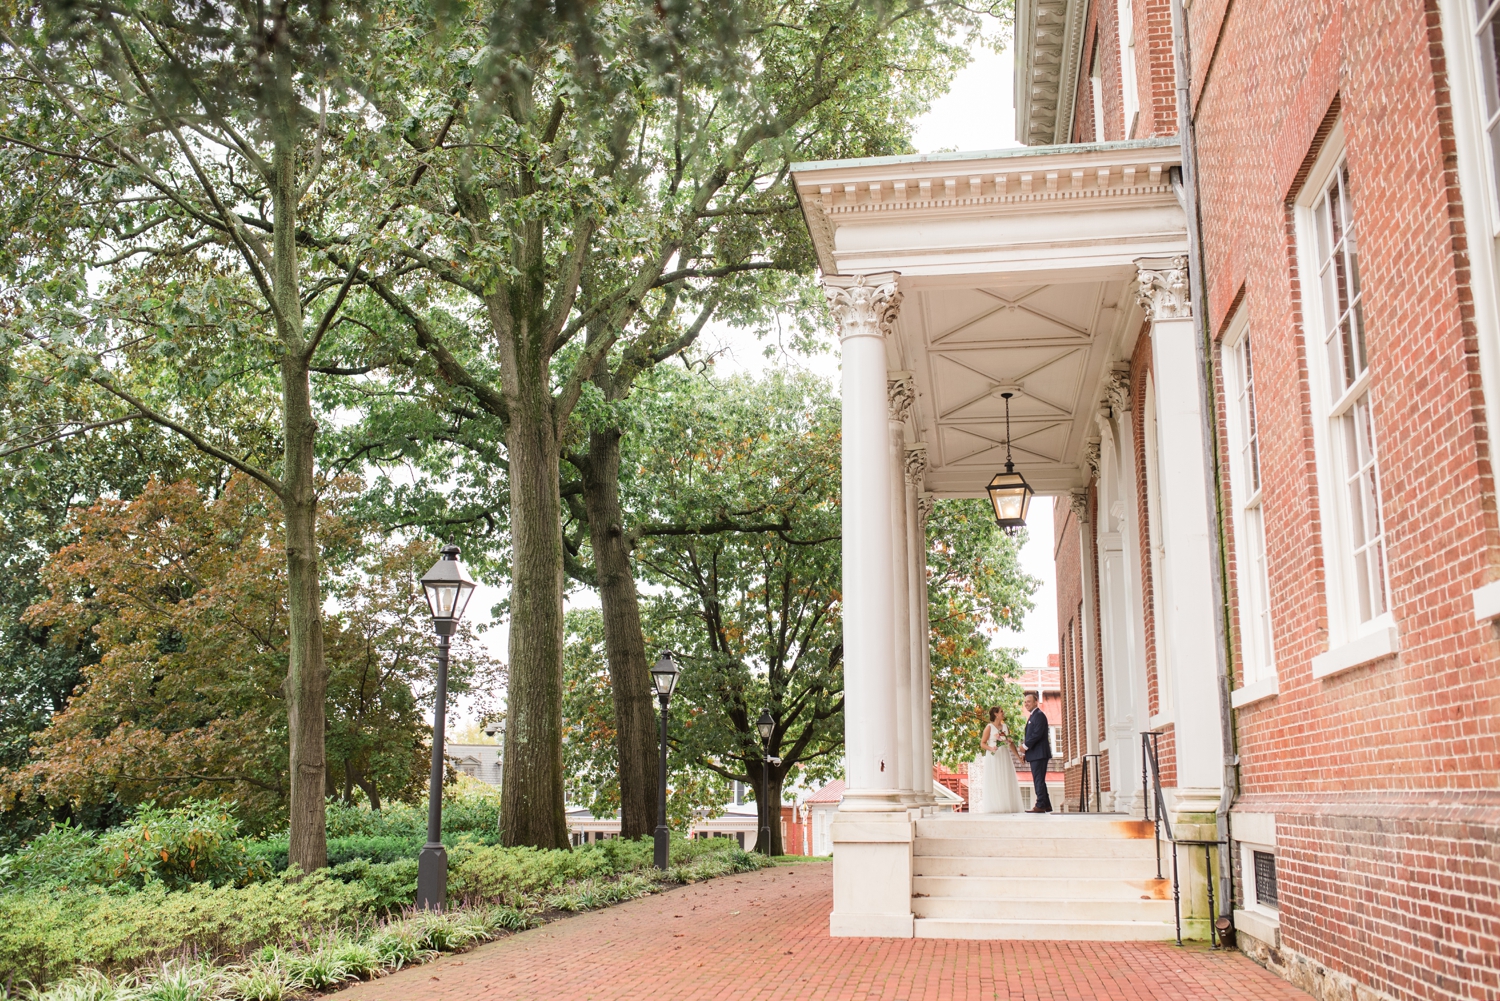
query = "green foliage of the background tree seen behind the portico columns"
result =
(564, 371, 1040, 836)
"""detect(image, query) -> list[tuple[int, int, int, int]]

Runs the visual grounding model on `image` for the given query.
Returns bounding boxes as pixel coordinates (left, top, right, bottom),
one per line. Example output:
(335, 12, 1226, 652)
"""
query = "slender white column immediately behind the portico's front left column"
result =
(885, 372, 917, 806)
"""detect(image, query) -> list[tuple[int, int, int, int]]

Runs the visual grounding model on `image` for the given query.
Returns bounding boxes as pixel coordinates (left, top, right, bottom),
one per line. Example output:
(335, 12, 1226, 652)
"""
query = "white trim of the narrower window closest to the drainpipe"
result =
(1220, 306, 1280, 708)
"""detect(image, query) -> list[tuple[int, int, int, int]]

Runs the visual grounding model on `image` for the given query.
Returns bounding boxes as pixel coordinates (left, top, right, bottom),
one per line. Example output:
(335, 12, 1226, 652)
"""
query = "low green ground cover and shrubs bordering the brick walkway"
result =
(0, 783, 767, 1001)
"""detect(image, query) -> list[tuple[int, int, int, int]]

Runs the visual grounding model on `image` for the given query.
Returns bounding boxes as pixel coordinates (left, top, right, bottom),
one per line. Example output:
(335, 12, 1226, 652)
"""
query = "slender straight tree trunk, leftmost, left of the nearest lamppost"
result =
(272, 108, 329, 872)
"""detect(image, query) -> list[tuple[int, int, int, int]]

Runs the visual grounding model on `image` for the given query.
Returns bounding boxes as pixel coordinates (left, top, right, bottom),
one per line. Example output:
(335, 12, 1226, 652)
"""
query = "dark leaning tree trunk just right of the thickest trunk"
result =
(584, 428, 660, 837)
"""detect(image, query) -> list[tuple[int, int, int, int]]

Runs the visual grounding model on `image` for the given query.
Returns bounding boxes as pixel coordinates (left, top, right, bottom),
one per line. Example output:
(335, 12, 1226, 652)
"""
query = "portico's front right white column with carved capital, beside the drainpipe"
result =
(1137, 257, 1223, 815)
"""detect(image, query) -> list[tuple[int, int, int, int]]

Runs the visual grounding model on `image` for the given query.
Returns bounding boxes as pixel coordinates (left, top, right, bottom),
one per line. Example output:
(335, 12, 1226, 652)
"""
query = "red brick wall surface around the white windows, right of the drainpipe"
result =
(1188, 0, 1500, 998)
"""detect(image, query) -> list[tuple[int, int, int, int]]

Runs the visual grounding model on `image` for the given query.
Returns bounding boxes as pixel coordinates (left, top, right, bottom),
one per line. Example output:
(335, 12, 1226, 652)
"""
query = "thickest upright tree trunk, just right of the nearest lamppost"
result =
(500, 356, 569, 848)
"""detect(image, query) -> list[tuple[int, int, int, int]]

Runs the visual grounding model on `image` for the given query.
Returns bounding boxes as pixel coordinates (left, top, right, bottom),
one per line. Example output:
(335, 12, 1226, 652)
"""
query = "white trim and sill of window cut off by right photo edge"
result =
(1439, 0, 1500, 627)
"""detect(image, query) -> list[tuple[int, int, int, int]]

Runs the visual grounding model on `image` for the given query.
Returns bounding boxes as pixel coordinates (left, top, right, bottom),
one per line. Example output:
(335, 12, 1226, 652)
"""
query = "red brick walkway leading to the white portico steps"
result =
(338, 864, 1308, 1001)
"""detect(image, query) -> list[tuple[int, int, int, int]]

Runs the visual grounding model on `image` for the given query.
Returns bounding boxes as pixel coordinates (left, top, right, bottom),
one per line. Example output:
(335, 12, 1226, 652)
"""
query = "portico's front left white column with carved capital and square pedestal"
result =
(824, 272, 914, 938)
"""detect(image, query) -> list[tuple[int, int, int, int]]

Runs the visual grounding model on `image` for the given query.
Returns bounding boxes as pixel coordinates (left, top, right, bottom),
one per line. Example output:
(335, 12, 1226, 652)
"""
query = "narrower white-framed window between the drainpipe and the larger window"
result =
(1221, 308, 1277, 705)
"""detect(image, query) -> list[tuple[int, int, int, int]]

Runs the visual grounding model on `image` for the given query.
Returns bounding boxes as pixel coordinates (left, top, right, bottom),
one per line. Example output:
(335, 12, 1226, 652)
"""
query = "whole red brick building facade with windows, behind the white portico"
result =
(1017, 0, 1500, 998)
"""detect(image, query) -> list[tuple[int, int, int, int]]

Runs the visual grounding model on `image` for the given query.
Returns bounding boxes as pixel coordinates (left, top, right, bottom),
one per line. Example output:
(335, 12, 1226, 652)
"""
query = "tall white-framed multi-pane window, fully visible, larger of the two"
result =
(1298, 123, 1394, 651)
